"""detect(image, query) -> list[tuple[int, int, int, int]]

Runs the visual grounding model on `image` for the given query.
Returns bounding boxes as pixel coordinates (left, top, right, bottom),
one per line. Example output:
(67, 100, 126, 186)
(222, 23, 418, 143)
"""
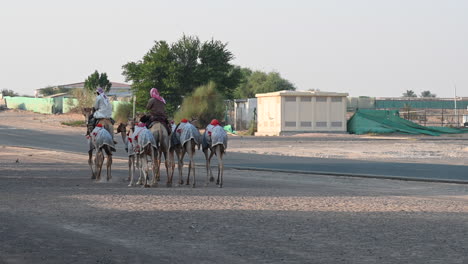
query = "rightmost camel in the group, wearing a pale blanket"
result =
(202, 120, 228, 188)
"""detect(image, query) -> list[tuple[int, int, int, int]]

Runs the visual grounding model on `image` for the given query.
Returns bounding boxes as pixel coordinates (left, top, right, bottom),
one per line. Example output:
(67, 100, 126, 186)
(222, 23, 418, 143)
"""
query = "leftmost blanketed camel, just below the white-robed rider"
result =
(88, 124, 115, 181)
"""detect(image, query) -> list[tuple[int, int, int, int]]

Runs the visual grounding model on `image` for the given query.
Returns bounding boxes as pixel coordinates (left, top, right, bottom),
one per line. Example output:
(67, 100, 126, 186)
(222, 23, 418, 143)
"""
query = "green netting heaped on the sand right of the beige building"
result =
(347, 109, 467, 136)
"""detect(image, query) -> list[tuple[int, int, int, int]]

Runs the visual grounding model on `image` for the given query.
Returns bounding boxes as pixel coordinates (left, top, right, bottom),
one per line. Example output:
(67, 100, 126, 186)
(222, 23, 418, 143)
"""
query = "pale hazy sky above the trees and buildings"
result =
(0, 0, 468, 97)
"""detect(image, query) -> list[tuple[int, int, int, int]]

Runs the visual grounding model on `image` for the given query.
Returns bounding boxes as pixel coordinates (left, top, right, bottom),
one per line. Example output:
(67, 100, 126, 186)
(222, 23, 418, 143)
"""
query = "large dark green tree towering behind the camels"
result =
(122, 35, 241, 115)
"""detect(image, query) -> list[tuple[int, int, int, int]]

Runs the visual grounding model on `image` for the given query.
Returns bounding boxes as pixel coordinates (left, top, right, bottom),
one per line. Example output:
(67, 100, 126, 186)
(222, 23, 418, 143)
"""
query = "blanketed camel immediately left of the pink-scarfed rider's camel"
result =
(130, 123, 158, 187)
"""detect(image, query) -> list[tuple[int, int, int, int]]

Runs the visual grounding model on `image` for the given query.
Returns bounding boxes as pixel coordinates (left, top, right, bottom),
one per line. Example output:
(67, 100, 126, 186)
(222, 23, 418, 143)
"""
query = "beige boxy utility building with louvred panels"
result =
(255, 91, 348, 136)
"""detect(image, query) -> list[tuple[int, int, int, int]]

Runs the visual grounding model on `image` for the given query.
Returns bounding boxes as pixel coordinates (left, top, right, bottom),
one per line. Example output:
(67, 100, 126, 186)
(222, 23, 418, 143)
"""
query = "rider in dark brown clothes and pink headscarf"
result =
(145, 88, 171, 134)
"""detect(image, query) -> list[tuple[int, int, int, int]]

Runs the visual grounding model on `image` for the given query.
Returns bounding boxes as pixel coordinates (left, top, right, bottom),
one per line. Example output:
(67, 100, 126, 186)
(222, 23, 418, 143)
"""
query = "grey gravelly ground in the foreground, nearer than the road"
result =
(0, 147, 468, 264)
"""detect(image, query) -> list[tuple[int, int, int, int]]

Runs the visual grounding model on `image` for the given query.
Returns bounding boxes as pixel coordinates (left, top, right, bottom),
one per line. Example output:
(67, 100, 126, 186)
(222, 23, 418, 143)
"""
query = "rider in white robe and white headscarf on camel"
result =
(90, 87, 115, 142)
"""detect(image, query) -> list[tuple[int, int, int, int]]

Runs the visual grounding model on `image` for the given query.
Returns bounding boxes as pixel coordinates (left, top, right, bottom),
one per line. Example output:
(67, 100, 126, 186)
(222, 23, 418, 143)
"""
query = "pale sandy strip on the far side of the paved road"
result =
(0, 110, 468, 165)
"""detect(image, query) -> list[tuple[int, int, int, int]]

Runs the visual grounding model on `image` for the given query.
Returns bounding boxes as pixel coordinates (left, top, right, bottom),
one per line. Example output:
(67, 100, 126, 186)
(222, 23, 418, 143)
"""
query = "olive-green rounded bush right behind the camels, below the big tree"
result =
(174, 82, 224, 127)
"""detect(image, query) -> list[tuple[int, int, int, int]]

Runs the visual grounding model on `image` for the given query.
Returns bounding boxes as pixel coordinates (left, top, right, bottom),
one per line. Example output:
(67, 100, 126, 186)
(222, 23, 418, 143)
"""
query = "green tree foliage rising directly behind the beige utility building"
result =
(234, 68, 296, 98)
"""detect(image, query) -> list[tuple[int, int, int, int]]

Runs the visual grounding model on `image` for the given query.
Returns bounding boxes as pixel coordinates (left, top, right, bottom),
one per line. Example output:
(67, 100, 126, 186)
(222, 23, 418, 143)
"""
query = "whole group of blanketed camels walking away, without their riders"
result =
(85, 109, 227, 188)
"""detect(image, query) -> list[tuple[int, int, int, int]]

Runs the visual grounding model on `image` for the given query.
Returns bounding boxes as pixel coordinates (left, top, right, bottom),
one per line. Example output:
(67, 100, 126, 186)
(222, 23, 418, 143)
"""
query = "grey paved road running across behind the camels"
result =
(0, 125, 468, 183)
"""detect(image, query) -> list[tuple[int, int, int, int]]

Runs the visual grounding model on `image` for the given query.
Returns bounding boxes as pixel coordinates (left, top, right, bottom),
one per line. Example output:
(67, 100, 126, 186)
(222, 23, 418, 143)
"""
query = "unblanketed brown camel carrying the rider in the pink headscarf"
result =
(150, 121, 174, 187)
